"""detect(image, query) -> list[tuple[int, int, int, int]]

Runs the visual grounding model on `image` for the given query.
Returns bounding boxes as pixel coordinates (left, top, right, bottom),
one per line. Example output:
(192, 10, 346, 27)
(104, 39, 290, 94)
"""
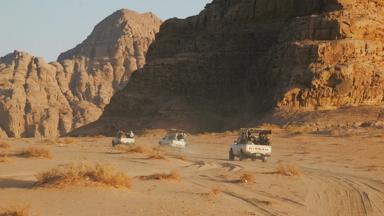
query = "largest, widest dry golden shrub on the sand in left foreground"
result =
(35, 164, 131, 188)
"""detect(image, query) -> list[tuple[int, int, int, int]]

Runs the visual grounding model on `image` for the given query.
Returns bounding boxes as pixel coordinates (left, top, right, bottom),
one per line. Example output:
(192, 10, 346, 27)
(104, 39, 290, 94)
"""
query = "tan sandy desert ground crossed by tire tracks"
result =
(0, 130, 384, 216)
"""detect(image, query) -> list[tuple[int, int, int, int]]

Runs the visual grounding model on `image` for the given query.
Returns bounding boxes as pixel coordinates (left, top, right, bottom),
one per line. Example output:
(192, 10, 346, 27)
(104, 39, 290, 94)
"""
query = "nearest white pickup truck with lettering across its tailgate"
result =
(229, 128, 272, 162)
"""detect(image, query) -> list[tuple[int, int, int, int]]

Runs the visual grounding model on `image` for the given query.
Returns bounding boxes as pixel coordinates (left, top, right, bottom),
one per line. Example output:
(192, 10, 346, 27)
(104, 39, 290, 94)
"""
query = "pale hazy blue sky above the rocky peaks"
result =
(0, 0, 211, 61)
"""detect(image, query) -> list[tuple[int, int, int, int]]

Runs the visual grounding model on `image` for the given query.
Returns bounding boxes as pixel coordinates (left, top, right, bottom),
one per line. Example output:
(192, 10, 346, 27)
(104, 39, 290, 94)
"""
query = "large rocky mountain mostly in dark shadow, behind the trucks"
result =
(78, 0, 384, 133)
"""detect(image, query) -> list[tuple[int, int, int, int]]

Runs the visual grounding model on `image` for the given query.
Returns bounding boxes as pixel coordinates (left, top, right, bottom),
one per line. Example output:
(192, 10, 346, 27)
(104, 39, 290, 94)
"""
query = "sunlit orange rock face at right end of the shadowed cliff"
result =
(277, 0, 384, 110)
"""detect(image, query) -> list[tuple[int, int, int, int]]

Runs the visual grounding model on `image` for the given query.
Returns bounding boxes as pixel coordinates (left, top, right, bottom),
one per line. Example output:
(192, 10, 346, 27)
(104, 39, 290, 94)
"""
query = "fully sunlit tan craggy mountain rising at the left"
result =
(0, 9, 161, 137)
